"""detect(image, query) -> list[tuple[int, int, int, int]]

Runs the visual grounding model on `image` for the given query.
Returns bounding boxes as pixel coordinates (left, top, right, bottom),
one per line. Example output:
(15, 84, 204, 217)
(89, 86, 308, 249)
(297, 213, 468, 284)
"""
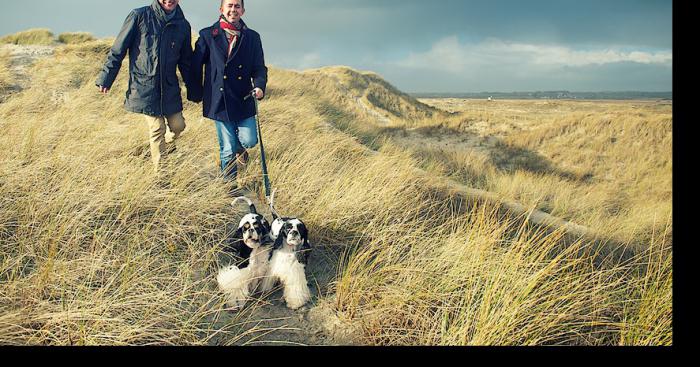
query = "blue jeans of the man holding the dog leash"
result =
(214, 116, 258, 181)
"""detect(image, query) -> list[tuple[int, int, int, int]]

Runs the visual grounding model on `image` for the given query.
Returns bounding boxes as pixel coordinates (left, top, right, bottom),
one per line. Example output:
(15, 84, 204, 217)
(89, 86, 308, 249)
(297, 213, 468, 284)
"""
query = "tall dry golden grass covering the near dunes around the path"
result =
(0, 36, 672, 345)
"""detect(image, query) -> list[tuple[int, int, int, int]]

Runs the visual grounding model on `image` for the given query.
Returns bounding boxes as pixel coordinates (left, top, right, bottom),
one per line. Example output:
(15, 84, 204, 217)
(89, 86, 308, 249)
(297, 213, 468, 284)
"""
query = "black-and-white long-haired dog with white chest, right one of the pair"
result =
(262, 192, 311, 310)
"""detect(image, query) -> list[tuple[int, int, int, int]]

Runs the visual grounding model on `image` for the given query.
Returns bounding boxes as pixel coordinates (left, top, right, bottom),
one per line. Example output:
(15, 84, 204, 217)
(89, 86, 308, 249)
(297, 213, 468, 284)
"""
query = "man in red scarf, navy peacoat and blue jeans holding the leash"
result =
(187, 0, 267, 189)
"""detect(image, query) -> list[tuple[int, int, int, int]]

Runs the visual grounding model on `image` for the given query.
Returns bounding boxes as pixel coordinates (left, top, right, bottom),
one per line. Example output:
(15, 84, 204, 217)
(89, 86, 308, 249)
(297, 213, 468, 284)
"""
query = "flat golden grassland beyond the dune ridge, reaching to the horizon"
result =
(348, 100, 673, 247)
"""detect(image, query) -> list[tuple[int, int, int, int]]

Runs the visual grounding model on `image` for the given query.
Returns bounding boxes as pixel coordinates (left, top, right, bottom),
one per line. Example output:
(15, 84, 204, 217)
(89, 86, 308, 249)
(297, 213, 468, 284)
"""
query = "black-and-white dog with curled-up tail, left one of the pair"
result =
(216, 197, 273, 309)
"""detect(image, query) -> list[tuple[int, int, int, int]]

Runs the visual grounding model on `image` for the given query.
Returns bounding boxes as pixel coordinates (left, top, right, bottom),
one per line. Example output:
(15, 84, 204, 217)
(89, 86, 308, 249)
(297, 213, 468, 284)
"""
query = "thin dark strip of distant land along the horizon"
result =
(409, 91, 673, 100)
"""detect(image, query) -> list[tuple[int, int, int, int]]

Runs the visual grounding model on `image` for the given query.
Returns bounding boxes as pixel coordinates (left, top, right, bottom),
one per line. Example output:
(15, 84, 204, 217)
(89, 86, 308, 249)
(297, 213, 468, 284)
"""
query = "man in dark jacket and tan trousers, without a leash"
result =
(95, 0, 192, 172)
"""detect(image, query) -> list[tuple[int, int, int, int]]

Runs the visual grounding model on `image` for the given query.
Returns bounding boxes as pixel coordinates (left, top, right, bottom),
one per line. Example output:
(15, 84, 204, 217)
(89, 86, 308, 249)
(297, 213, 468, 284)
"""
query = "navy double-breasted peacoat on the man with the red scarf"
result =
(187, 21, 267, 122)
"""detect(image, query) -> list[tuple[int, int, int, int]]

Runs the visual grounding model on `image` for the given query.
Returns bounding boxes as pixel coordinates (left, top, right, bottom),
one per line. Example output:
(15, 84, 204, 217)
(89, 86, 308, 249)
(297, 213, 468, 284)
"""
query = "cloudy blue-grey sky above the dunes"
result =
(0, 0, 673, 92)
